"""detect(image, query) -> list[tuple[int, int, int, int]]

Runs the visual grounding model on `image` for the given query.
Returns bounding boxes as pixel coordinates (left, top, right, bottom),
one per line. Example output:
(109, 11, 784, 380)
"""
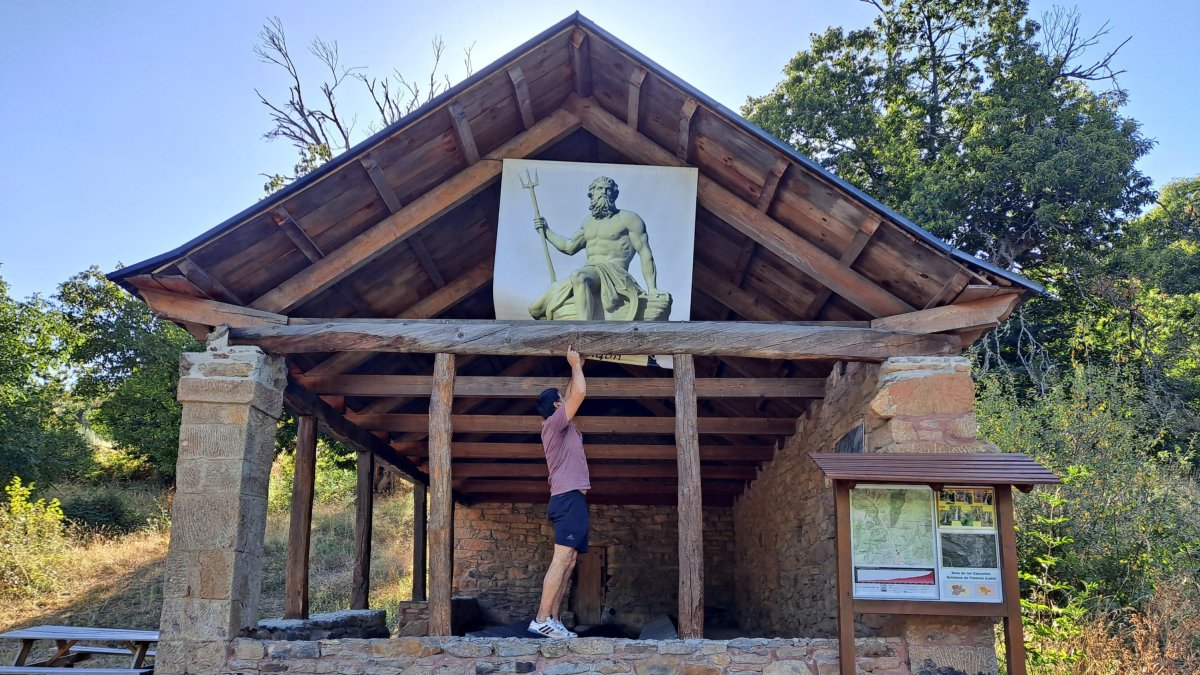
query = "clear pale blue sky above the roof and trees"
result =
(0, 0, 1200, 298)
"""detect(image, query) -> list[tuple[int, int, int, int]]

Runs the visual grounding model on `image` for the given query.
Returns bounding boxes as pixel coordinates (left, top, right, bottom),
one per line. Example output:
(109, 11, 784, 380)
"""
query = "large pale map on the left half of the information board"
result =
(850, 485, 937, 568)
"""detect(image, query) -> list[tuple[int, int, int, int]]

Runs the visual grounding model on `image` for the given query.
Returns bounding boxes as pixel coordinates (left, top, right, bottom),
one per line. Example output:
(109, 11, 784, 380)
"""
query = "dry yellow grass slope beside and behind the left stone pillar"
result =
(0, 482, 413, 663)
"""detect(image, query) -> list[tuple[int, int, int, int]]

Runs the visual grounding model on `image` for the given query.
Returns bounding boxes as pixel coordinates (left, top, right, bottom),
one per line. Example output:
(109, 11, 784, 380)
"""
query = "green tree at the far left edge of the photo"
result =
(0, 270, 90, 484)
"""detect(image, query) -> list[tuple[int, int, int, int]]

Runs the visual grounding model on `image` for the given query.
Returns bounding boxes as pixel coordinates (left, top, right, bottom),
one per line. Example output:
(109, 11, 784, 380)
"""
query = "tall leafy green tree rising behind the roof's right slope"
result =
(743, 0, 1151, 273)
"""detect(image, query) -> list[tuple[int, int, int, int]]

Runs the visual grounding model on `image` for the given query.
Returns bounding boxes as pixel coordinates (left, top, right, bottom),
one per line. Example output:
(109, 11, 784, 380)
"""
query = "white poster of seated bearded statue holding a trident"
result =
(492, 160, 697, 365)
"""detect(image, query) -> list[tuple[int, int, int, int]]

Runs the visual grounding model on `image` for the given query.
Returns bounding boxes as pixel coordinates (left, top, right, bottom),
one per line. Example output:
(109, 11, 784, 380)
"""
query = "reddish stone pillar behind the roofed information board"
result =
(865, 357, 1000, 675)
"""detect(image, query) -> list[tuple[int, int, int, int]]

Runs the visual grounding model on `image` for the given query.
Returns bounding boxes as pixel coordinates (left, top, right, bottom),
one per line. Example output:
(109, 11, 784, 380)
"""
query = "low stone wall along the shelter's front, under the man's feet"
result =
(223, 638, 912, 675)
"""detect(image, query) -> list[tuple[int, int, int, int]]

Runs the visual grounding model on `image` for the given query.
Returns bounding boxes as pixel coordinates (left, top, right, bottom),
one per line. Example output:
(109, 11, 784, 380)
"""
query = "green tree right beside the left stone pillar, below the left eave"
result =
(56, 267, 203, 478)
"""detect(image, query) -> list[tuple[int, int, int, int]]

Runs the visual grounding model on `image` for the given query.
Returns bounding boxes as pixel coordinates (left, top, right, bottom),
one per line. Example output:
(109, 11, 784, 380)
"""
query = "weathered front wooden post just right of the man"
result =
(674, 354, 704, 639)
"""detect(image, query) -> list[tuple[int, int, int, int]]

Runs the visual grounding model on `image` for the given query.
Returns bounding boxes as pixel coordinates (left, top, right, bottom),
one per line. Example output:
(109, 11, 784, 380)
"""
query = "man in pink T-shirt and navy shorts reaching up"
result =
(529, 347, 592, 638)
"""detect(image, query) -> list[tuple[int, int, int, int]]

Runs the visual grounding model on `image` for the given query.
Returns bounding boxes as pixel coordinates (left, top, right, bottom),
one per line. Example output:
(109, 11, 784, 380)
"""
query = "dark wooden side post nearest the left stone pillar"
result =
(283, 414, 317, 619)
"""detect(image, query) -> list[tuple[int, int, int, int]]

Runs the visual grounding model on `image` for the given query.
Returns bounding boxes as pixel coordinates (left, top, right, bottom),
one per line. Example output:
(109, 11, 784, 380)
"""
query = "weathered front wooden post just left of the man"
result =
(428, 354, 455, 635)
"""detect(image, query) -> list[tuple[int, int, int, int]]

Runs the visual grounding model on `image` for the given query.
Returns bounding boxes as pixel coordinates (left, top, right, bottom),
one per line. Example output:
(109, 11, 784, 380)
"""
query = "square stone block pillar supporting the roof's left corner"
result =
(155, 335, 287, 674)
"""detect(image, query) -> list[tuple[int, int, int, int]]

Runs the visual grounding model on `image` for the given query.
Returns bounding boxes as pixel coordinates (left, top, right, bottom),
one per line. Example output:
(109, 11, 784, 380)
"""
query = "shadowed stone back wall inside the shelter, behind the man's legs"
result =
(454, 503, 734, 632)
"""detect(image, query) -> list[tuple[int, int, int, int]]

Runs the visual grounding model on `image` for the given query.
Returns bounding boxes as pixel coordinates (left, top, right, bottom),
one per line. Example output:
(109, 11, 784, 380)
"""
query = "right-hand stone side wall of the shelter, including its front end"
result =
(734, 357, 997, 674)
